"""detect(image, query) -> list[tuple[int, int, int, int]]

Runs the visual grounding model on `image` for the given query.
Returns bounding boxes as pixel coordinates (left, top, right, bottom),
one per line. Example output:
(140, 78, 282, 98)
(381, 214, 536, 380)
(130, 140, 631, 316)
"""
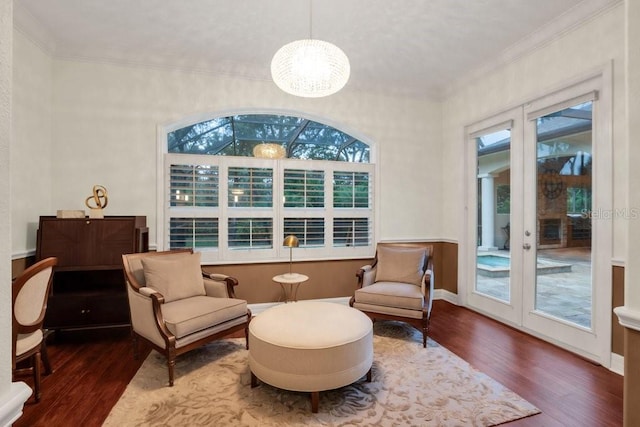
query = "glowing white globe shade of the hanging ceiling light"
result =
(271, 39, 351, 98)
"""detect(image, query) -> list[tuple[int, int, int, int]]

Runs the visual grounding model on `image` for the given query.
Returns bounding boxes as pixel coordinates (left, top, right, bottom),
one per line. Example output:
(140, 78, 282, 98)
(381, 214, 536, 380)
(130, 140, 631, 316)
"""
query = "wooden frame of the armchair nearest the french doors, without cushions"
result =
(349, 244, 434, 348)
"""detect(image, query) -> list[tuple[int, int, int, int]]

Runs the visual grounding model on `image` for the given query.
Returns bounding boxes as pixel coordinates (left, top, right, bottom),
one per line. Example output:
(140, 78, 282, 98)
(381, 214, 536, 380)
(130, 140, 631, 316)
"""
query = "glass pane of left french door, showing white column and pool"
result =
(475, 130, 511, 302)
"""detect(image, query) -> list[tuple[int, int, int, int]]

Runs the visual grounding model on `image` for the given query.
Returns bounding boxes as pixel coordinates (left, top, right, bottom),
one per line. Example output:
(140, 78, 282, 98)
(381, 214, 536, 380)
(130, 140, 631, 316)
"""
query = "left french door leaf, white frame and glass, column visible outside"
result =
(464, 108, 524, 327)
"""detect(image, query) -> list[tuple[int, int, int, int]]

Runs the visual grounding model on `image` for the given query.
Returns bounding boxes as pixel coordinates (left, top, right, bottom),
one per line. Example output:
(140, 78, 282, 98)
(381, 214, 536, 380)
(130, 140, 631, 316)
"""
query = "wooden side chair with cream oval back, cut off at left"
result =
(11, 257, 58, 402)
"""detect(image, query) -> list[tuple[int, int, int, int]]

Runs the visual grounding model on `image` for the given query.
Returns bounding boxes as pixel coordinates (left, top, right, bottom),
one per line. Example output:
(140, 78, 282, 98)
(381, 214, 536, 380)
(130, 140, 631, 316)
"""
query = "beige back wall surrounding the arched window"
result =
(33, 50, 441, 251)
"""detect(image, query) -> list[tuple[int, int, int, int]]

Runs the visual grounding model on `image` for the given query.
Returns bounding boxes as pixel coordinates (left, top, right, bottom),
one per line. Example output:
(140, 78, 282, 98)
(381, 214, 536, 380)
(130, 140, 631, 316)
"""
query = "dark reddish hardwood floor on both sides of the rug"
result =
(14, 301, 623, 427)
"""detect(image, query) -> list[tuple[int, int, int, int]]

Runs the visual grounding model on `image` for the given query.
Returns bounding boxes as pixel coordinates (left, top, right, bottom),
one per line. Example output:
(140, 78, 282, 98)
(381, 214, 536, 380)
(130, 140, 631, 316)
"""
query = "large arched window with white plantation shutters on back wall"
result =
(158, 114, 375, 263)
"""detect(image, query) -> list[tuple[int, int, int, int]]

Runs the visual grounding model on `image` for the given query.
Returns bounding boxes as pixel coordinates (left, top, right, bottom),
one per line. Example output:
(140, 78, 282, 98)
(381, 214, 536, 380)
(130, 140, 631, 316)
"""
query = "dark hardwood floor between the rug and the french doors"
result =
(430, 301, 624, 427)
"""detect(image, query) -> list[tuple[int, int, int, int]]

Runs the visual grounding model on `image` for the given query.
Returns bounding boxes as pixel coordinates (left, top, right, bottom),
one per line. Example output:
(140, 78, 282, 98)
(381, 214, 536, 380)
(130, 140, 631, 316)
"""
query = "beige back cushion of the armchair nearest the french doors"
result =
(376, 246, 427, 286)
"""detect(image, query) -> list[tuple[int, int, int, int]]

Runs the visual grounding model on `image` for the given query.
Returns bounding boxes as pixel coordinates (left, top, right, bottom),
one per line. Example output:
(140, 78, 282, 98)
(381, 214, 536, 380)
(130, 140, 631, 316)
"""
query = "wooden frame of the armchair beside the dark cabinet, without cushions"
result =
(122, 249, 251, 386)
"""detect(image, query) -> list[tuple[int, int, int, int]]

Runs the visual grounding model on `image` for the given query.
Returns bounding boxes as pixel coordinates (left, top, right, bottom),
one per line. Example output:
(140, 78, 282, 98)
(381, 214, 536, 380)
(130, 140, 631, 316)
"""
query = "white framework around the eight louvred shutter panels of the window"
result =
(156, 132, 377, 264)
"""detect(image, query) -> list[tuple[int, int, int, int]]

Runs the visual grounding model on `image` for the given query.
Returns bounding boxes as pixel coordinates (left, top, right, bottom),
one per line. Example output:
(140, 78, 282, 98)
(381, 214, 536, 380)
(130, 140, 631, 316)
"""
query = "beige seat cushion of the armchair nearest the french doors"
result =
(355, 282, 424, 310)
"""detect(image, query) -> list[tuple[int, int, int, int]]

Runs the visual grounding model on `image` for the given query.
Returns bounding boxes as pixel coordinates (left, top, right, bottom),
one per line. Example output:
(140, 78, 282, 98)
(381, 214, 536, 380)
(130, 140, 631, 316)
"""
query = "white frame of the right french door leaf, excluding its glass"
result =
(523, 75, 613, 367)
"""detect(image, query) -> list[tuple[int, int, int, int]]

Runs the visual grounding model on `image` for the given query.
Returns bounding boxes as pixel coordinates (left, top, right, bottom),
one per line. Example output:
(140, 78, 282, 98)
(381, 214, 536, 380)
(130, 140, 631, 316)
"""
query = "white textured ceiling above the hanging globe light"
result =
(14, 0, 619, 97)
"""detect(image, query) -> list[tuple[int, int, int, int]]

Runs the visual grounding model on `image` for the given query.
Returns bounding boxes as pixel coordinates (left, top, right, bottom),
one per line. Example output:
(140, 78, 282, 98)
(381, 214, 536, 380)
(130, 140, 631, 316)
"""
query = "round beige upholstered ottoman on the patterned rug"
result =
(249, 301, 373, 412)
